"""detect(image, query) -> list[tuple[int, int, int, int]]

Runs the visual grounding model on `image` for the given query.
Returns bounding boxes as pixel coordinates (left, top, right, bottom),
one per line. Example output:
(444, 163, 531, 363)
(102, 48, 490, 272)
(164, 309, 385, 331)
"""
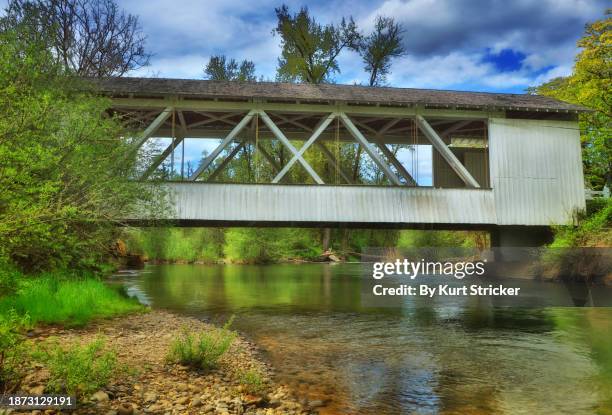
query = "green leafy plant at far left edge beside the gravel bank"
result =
(0, 310, 29, 393)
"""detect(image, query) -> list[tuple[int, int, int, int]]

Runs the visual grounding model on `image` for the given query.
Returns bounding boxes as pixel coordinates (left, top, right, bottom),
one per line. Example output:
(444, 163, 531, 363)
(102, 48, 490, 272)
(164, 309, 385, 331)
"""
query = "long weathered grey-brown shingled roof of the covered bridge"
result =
(93, 77, 585, 112)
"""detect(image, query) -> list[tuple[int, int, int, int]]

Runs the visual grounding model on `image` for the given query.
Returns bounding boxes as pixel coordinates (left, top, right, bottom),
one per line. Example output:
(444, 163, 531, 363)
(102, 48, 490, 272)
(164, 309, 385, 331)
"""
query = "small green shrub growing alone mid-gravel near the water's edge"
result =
(168, 317, 236, 370)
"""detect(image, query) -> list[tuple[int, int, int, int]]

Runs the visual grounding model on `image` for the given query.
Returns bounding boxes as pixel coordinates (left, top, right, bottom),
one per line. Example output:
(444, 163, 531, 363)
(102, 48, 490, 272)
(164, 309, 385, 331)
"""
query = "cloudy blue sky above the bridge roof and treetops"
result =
(112, 0, 606, 93)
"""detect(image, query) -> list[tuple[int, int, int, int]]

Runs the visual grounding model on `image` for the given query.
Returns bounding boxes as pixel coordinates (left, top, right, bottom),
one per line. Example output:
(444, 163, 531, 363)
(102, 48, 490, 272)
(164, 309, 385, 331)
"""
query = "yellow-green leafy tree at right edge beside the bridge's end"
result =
(529, 10, 612, 189)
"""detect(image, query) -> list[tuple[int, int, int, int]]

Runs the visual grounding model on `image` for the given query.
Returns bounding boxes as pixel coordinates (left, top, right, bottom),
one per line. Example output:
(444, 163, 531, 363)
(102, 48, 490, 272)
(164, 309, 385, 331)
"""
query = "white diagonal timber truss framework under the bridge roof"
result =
(110, 97, 492, 188)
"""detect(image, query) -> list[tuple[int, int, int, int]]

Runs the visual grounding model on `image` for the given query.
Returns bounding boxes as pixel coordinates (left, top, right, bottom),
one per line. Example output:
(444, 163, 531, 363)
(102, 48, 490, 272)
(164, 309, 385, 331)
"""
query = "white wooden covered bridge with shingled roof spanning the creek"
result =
(96, 78, 585, 245)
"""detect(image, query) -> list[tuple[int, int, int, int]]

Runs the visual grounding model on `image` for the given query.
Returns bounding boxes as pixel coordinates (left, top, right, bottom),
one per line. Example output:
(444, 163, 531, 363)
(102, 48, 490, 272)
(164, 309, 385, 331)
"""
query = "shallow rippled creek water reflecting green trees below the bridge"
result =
(116, 264, 612, 415)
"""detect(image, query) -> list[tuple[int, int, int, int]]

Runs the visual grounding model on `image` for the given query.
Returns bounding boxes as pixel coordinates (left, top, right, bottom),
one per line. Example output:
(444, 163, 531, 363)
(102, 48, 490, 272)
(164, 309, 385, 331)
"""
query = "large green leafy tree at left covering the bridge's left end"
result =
(0, 17, 165, 271)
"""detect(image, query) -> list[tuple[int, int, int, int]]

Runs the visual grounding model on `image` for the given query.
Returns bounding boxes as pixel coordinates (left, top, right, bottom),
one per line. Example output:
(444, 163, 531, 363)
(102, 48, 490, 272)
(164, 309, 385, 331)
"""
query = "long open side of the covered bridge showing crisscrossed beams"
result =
(126, 110, 490, 188)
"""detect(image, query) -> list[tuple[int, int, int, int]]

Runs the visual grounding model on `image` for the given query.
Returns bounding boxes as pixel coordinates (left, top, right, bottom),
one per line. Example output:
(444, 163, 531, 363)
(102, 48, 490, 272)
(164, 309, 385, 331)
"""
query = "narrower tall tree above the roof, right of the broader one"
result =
(358, 16, 405, 86)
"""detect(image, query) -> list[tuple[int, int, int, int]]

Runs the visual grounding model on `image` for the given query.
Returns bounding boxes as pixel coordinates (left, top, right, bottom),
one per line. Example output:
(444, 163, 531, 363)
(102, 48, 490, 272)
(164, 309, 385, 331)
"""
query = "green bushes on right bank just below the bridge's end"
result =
(550, 199, 612, 248)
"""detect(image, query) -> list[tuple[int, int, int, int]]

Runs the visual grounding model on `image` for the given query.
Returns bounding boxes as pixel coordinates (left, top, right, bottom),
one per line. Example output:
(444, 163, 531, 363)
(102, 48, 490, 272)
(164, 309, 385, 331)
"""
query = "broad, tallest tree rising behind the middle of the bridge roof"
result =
(274, 5, 360, 84)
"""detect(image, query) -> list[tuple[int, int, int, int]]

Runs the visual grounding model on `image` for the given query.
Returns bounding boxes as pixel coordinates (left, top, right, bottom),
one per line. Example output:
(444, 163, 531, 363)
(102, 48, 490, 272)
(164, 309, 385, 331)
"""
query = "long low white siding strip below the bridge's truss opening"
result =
(168, 182, 496, 224)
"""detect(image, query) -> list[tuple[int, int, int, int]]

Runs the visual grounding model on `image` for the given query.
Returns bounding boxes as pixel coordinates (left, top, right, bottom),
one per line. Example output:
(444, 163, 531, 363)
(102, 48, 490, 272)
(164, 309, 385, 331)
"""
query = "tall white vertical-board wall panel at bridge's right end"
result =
(489, 118, 585, 226)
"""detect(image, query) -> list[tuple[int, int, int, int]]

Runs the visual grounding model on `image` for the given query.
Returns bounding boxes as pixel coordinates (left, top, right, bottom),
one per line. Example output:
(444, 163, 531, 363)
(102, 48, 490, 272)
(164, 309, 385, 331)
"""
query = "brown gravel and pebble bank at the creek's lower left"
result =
(14, 311, 318, 415)
